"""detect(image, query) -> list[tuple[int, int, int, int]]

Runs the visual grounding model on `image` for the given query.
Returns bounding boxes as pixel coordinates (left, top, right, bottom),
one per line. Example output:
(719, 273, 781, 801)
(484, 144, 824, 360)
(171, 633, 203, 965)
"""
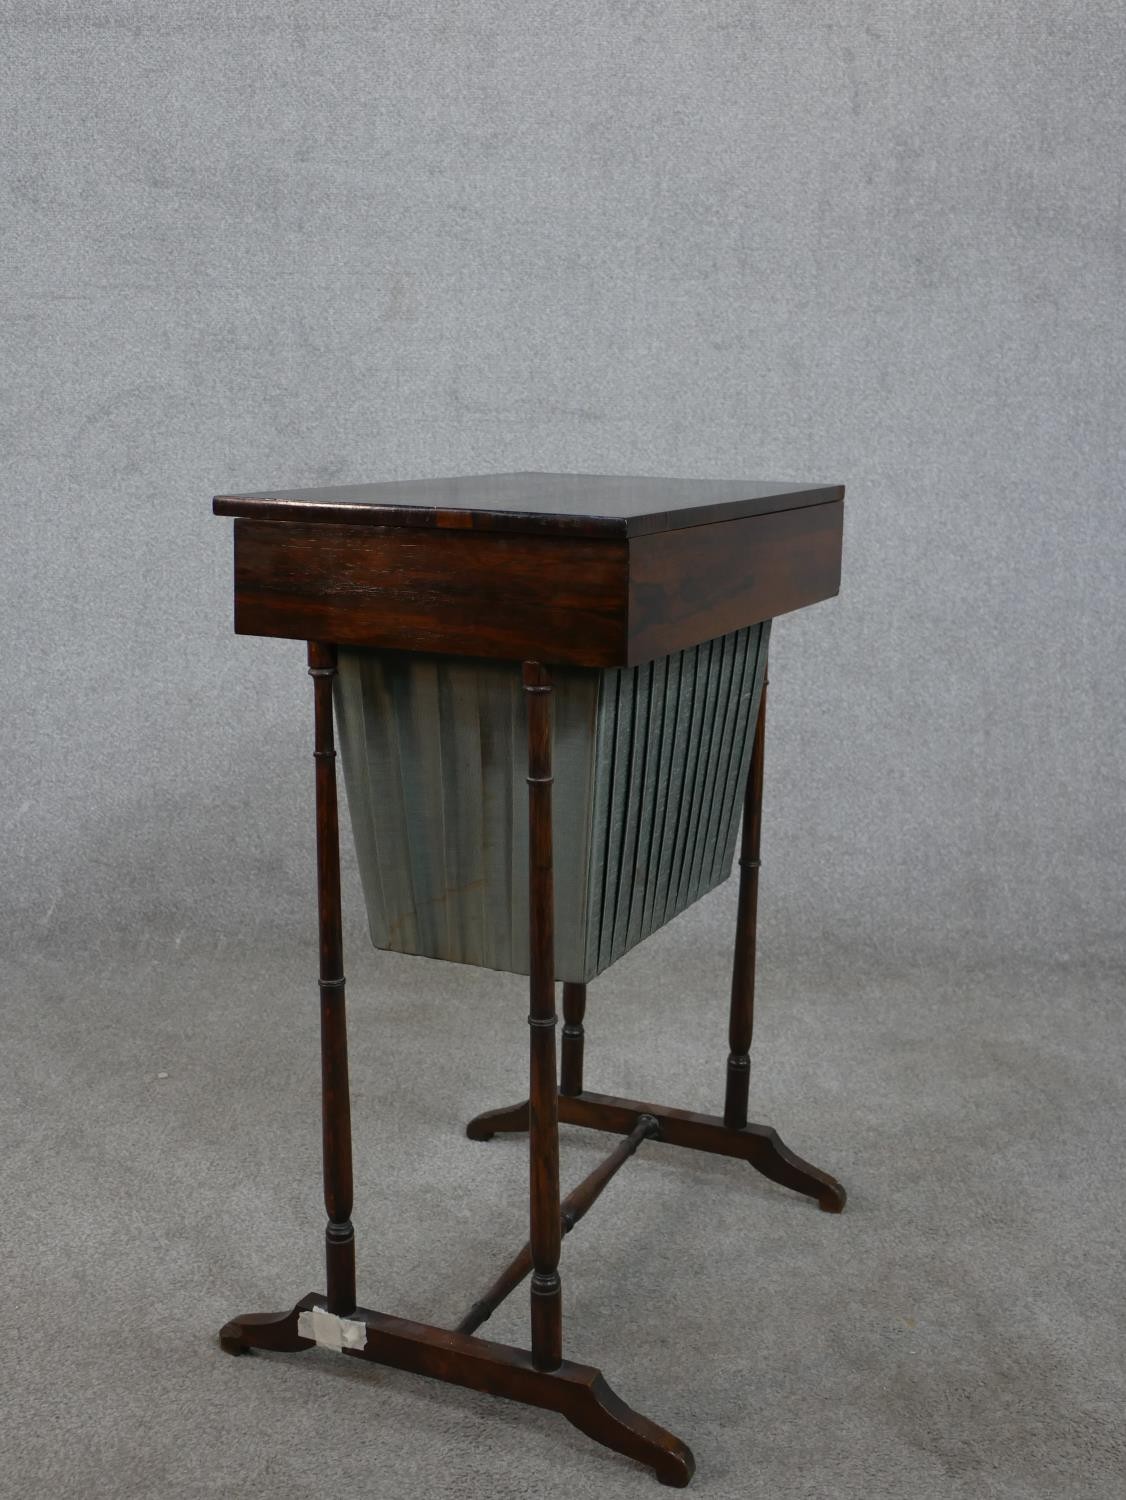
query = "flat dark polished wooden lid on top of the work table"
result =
(213, 474, 844, 539)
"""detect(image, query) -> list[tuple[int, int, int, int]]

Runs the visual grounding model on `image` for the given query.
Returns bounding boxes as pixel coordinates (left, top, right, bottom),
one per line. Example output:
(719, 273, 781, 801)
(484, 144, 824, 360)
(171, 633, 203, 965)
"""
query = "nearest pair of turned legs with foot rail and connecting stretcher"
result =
(219, 644, 694, 1487)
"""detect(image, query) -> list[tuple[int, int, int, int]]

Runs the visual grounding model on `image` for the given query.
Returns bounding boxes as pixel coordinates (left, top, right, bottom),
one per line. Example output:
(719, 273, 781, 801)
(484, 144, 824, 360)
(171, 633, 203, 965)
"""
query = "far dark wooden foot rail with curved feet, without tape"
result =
(465, 1094, 847, 1214)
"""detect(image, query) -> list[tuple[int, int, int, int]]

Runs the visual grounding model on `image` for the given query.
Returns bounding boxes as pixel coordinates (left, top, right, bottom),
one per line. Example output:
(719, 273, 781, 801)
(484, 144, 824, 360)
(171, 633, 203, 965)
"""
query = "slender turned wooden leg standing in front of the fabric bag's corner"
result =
(523, 662, 562, 1370)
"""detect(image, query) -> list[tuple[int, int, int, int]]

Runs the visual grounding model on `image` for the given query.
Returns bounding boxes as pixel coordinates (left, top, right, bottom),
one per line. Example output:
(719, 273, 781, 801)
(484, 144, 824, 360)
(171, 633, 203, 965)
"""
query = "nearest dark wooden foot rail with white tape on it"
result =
(220, 1295, 696, 1488)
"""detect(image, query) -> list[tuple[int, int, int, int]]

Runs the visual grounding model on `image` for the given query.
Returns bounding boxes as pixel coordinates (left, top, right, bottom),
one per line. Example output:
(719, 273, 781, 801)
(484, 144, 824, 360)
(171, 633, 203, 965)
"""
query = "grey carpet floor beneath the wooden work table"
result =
(0, 890, 1126, 1500)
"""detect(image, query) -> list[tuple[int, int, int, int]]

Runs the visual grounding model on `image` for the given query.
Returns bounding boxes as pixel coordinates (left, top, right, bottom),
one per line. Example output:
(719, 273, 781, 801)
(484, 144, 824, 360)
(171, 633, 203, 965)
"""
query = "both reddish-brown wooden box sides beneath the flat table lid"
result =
(235, 501, 843, 666)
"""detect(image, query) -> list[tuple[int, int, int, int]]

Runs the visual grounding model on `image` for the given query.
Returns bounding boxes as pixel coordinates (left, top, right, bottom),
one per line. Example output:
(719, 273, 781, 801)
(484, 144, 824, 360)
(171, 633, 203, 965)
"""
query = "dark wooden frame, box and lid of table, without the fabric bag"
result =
(216, 476, 846, 1487)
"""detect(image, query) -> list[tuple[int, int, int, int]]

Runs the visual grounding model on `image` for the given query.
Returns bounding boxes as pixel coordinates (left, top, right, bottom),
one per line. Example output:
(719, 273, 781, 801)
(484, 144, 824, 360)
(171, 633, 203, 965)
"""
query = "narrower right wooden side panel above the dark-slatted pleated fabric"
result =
(628, 501, 844, 665)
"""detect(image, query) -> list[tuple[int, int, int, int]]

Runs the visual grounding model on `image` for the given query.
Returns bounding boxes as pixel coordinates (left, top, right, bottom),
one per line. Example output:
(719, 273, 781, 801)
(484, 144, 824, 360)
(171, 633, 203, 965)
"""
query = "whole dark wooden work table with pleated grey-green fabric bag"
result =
(214, 474, 844, 1485)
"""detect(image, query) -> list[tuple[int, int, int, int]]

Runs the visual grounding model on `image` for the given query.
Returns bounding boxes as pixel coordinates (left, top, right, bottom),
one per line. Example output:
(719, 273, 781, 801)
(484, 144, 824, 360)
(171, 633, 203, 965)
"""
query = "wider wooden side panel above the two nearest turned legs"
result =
(234, 521, 628, 666)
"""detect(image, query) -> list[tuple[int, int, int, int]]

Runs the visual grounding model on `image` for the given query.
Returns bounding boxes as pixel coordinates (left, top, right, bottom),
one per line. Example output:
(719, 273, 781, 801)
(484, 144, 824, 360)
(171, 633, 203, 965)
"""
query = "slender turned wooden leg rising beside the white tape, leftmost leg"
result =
(309, 641, 355, 1314)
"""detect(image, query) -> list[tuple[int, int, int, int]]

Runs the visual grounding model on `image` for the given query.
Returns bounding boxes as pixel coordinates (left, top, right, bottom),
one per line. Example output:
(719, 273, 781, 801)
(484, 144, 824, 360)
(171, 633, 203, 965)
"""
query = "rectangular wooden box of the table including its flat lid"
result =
(214, 462, 844, 666)
